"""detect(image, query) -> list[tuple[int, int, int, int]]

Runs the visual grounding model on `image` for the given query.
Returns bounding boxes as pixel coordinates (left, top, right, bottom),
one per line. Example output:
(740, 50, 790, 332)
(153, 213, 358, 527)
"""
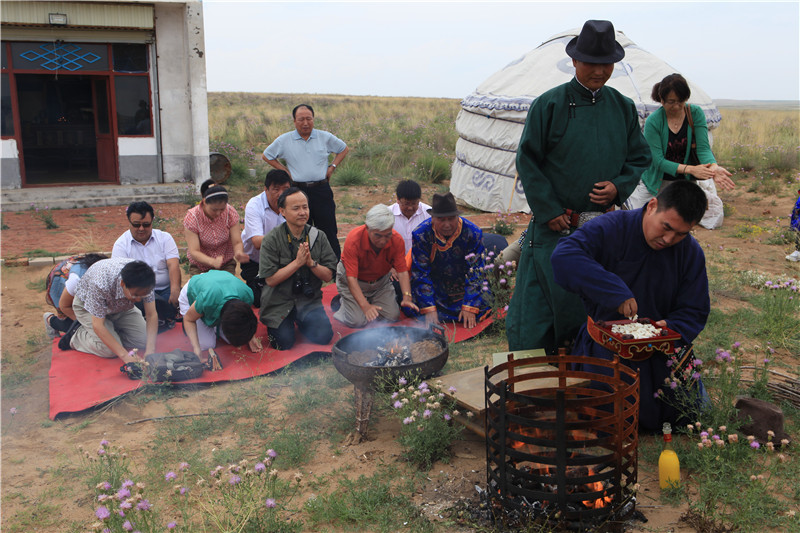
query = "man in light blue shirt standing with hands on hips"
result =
(261, 104, 349, 259)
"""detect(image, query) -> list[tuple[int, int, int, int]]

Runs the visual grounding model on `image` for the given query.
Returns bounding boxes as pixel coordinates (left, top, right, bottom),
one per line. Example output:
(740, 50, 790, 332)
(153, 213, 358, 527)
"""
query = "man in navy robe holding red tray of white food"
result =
(551, 180, 710, 431)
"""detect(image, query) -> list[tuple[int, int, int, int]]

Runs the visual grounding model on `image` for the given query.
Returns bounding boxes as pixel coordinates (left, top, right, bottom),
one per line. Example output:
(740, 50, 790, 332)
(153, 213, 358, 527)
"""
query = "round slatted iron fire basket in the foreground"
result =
(485, 355, 639, 530)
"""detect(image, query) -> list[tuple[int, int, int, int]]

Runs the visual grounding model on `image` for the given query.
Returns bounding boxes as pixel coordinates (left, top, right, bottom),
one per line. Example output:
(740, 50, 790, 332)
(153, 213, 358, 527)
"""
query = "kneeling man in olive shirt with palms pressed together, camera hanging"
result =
(258, 187, 336, 350)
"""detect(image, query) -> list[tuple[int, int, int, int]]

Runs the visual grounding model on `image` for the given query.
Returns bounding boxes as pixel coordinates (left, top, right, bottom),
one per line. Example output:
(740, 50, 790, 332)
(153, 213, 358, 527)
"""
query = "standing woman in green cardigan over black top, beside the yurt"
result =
(625, 74, 734, 209)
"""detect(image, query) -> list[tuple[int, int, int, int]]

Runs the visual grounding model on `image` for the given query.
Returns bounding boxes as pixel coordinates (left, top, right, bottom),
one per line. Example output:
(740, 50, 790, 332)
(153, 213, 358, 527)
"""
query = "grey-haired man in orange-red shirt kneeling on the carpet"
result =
(333, 204, 419, 328)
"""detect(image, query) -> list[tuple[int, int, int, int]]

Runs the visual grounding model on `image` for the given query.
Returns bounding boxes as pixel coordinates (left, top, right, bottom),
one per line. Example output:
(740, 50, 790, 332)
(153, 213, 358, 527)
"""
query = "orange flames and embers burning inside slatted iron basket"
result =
(509, 426, 613, 509)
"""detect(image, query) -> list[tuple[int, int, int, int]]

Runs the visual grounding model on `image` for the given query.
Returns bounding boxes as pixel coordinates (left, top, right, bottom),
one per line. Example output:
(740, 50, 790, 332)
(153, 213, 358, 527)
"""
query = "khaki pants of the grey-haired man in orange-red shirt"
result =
(333, 262, 400, 328)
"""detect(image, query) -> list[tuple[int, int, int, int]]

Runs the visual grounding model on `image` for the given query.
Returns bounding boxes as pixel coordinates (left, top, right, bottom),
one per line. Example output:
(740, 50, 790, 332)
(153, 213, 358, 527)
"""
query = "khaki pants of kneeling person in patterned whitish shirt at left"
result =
(70, 296, 147, 359)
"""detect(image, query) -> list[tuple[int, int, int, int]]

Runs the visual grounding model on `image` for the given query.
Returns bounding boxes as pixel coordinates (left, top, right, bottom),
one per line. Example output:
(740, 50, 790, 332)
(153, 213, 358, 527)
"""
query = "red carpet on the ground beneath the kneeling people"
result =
(49, 284, 492, 420)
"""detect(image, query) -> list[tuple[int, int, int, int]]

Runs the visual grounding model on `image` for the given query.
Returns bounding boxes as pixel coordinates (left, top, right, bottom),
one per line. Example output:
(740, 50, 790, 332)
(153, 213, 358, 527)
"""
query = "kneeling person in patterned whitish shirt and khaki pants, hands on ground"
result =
(62, 258, 158, 363)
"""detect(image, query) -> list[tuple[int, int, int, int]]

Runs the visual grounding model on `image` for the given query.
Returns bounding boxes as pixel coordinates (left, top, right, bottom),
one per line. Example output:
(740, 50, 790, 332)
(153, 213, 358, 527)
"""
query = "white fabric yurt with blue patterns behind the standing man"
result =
(450, 28, 721, 213)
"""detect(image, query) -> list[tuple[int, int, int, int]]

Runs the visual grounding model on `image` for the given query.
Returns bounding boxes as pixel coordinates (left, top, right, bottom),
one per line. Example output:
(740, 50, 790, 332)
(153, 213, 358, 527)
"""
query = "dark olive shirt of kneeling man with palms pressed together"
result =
(258, 222, 337, 328)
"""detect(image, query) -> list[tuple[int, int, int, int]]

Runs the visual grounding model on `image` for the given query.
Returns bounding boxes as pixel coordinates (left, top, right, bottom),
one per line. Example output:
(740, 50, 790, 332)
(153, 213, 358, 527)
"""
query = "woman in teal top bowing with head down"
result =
(178, 270, 261, 357)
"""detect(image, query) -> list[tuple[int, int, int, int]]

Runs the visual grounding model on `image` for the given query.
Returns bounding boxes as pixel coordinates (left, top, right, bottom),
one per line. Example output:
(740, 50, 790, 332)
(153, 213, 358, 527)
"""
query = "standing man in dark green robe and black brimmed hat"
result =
(506, 20, 651, 352)
